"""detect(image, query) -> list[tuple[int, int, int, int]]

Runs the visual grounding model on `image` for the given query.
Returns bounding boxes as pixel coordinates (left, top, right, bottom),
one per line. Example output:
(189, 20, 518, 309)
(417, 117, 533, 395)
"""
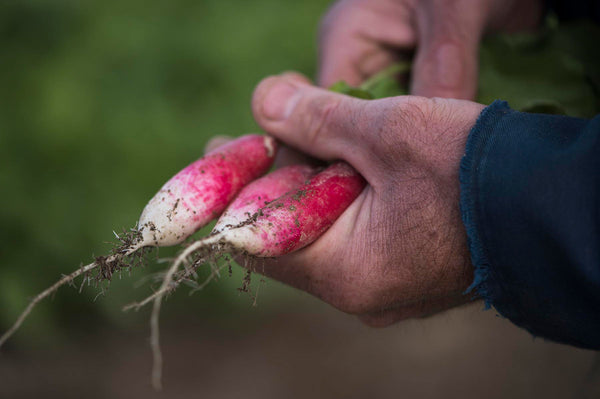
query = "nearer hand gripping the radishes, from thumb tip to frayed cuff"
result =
(250, 73, 483, 326)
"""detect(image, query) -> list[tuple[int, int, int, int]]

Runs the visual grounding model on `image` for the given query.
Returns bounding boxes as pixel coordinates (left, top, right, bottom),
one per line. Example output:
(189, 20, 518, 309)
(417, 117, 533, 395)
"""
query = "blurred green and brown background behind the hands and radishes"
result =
(0, 0, 598, 398)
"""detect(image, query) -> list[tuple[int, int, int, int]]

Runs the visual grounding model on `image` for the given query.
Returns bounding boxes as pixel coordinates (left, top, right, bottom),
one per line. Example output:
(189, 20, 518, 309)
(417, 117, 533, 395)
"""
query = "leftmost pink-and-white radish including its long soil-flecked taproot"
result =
(0, 135, 276, 347)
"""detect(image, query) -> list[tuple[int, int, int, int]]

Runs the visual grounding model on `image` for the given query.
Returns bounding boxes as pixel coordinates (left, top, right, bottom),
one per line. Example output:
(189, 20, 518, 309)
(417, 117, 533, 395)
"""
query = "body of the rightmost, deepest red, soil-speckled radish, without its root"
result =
(225, 162, 366, 257)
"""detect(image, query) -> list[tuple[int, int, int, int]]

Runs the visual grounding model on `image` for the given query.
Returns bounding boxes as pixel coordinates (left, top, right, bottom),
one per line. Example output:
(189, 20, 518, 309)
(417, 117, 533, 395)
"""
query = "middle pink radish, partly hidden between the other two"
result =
(213, 165, 317, 233)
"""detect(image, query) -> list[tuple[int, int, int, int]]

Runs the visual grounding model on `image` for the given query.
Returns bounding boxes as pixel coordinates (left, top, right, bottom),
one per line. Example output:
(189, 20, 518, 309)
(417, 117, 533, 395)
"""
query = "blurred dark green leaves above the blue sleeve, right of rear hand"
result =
(478, 18, 600, 117)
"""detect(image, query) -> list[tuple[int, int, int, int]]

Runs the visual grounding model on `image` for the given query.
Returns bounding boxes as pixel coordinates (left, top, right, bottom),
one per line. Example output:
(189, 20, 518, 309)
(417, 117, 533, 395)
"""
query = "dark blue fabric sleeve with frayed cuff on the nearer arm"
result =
(460, 101, 600, 349)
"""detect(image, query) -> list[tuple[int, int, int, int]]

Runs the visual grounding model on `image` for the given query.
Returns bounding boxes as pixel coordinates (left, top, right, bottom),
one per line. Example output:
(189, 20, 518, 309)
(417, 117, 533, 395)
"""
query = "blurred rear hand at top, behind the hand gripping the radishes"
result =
(318, 0, 542, 99)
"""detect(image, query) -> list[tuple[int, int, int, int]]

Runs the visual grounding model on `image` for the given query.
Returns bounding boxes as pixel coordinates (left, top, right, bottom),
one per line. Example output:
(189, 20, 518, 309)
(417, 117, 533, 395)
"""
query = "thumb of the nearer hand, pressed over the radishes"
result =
(252, 74, 366, 163)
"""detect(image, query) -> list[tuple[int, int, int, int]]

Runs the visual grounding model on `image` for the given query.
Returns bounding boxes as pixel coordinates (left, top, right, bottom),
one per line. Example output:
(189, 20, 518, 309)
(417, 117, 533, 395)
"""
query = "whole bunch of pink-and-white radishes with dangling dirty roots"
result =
(0, 135, 365, 388)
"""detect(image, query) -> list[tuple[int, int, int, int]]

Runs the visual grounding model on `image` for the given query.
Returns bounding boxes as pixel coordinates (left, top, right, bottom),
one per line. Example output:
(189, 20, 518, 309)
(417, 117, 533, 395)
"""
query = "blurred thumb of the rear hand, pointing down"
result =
(411, 2, 481, 100)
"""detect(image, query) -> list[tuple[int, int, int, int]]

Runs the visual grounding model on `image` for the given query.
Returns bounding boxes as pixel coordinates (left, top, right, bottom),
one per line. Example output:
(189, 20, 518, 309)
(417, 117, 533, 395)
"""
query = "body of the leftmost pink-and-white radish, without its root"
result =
(136, 135, 276, 248)
